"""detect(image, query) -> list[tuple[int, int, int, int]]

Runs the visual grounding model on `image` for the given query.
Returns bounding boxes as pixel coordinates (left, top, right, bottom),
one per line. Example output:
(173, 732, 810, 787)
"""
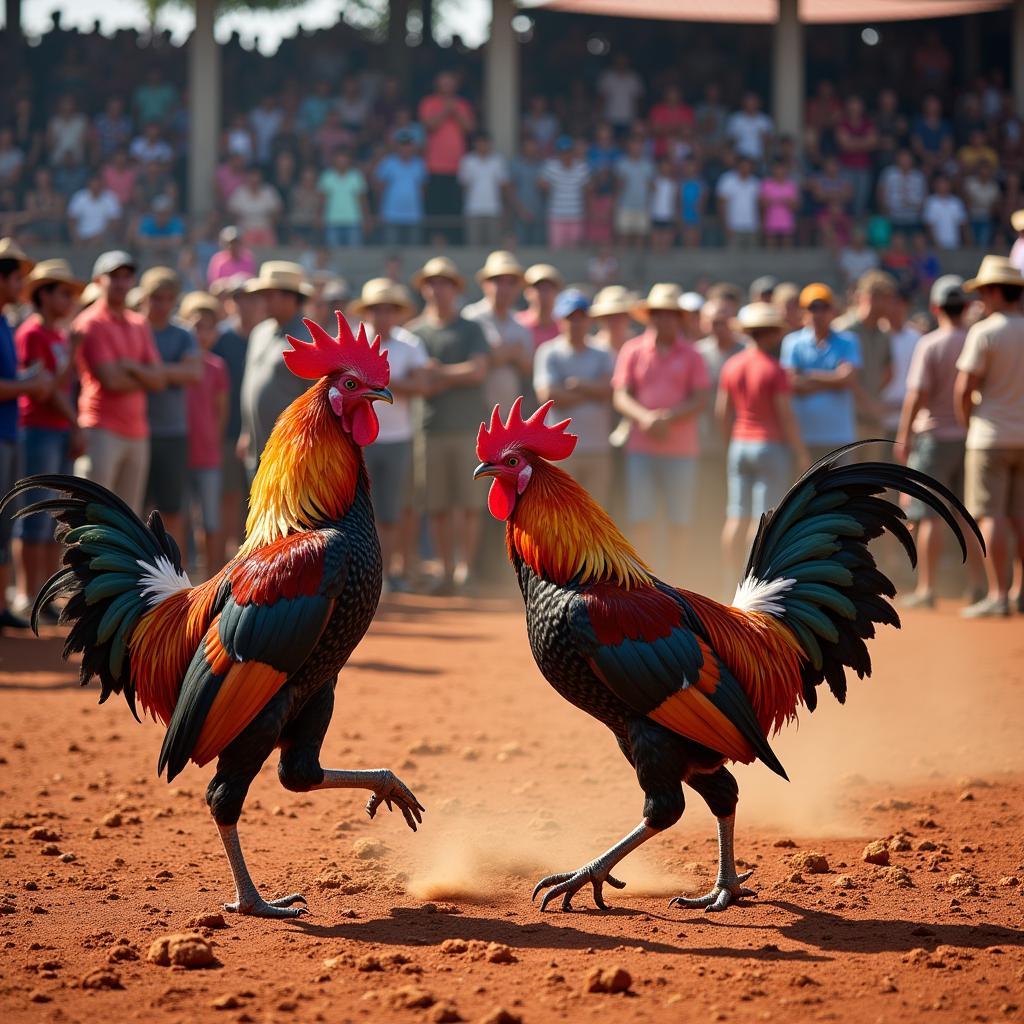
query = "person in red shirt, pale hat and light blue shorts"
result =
(715, 302, 809, 585)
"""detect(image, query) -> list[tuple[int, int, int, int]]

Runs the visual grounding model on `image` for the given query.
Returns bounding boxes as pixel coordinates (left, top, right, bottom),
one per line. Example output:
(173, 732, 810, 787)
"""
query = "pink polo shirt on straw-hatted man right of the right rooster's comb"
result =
(611, 330, 711, 458)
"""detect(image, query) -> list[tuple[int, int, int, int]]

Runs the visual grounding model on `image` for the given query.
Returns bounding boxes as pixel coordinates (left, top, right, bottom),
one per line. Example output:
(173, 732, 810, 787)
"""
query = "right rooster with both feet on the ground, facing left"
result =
(474, 398, 982, 910)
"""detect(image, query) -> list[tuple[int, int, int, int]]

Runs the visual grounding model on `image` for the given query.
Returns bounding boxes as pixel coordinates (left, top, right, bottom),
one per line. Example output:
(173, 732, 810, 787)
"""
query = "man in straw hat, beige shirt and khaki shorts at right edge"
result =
(953, 256, 1024, 618)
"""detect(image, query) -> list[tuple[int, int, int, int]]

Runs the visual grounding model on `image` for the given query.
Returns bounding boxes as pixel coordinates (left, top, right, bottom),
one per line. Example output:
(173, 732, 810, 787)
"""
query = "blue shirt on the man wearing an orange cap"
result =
(779, 327, 861, 447)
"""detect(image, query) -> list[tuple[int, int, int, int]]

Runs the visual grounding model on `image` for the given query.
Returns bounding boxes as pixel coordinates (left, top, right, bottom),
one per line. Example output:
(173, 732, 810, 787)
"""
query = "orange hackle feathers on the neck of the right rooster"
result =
(509, 460, 651, 589)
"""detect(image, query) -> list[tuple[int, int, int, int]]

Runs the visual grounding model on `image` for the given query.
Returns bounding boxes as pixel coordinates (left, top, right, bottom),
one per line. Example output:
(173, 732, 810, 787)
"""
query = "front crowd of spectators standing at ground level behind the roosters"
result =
(0, 229, 1024, 628)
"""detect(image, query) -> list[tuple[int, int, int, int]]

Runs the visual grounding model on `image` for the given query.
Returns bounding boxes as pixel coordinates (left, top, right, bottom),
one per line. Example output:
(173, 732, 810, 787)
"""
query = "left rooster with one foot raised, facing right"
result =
(4, 313, 423, 918)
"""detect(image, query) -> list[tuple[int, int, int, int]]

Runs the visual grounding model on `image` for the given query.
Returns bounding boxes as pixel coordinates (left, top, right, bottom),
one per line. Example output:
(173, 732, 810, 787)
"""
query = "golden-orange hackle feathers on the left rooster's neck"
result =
(239, 380, 364, 556)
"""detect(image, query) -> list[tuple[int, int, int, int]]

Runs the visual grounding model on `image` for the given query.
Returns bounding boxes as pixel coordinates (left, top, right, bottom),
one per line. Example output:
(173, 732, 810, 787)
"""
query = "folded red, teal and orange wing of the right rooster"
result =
(568, 584, 785, 777)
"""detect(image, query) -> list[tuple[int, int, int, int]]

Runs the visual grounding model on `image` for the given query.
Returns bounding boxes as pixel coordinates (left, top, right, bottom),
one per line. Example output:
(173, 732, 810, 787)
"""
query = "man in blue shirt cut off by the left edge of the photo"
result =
(0, 239, 53, 630)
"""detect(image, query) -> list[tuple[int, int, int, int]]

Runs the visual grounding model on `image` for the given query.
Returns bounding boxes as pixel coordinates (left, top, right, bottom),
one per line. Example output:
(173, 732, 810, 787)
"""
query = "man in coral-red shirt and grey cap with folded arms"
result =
(72, 250, 164, 515)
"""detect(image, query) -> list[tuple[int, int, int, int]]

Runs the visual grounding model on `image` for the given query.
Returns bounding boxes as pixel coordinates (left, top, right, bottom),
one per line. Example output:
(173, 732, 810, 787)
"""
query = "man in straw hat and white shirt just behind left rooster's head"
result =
(349, 278, 430, 593)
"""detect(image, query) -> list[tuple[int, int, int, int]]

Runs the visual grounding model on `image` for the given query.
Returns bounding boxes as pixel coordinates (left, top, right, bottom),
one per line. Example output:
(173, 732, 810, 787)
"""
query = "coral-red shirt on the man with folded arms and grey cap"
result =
(74, 299, 160, 438)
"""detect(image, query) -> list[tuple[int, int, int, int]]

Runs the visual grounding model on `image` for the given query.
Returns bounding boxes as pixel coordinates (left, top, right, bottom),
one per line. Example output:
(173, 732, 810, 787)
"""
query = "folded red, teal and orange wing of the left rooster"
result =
(159, 530, 348, 781)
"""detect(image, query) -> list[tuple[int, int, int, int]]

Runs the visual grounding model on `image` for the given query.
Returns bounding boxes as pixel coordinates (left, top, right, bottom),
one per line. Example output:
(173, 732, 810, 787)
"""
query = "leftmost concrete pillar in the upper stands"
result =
(188, 0, 221, 217)
